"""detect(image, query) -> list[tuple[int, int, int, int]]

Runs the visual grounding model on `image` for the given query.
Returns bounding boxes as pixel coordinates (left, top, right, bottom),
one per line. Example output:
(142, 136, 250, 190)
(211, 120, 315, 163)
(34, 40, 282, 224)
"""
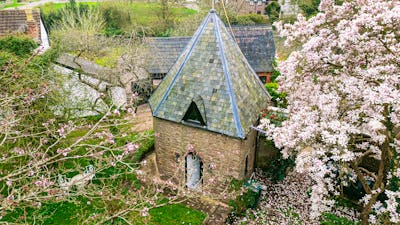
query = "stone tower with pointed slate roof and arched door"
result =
(149, 10, 270, 194)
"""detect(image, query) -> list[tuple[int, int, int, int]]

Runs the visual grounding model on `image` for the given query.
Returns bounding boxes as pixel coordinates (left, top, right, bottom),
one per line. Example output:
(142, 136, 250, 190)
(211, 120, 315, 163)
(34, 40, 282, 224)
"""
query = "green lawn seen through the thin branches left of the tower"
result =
(0, 126, 206, 225)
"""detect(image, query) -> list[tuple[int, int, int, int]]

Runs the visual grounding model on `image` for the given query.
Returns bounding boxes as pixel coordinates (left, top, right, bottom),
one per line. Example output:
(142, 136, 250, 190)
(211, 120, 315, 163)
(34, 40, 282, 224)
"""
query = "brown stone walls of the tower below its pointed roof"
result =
(153, 118, 255, 195)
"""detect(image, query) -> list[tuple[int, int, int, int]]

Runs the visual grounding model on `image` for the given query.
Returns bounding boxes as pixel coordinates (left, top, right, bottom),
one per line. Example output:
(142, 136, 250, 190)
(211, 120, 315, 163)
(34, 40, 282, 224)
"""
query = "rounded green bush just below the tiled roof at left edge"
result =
(0, 35, 38, 56)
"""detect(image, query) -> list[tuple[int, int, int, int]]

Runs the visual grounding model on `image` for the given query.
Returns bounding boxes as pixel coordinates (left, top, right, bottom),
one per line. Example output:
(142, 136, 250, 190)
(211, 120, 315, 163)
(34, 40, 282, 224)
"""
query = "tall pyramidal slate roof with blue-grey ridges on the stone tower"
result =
(149, 10, 270, 138)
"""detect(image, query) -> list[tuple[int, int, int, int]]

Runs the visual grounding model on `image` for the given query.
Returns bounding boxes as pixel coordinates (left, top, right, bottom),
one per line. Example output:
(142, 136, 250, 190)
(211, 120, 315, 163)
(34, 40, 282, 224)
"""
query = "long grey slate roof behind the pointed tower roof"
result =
(146, 25, 275, 74)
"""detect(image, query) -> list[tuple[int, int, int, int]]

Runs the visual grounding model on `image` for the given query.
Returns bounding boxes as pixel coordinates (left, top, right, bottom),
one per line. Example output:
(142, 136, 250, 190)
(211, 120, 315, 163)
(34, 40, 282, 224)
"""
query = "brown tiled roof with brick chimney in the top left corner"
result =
(0, 9, 40, 42)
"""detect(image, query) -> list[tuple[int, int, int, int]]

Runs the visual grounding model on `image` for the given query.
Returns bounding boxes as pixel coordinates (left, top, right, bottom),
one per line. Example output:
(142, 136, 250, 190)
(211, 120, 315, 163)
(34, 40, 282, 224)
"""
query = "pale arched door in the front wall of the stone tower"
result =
(186, 153, 203, 189)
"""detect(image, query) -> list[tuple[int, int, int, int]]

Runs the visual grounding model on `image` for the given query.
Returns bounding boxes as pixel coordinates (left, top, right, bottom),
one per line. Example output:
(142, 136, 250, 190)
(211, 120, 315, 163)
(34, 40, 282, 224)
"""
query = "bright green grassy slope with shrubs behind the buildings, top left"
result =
(41, 1, 197, 37)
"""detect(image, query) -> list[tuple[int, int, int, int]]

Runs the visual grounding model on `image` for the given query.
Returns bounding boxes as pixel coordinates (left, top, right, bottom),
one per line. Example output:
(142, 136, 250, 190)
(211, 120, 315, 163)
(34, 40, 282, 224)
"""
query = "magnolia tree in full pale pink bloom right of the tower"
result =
(261, 0, 400, 224)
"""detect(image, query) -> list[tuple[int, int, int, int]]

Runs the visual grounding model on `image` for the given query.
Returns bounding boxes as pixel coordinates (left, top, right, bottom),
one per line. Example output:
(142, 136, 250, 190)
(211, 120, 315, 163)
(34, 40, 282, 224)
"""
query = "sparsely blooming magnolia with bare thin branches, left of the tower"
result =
(0, 37, 180, 224)
